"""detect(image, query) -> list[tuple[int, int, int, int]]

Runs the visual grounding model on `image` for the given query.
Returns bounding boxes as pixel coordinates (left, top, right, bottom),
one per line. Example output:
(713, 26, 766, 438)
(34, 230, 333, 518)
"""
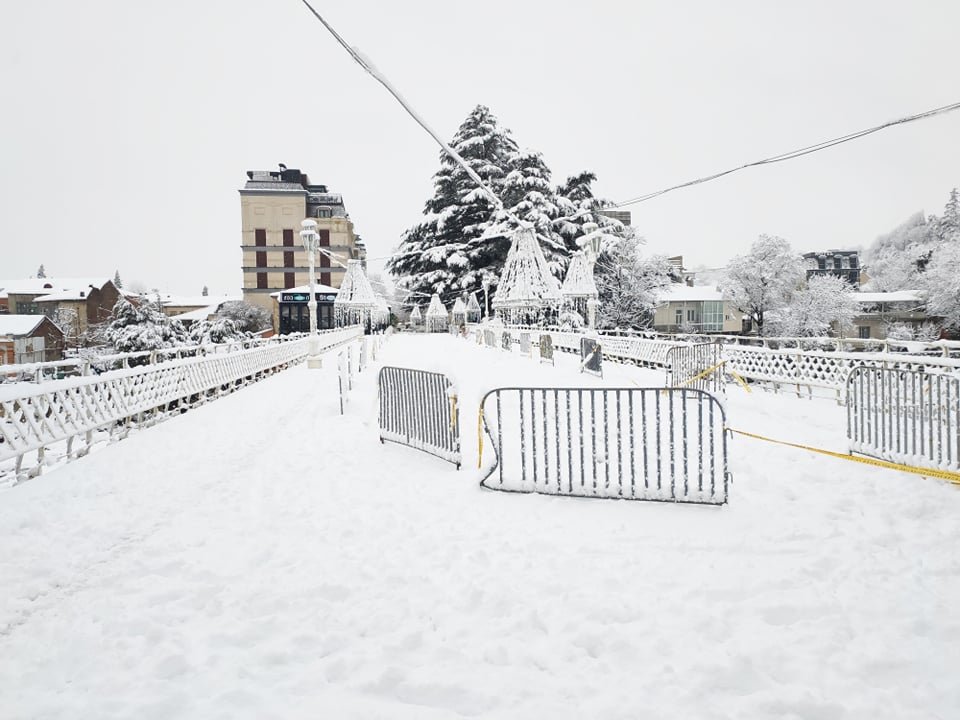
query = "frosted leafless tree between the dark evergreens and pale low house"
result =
(595, 238, 673, 328)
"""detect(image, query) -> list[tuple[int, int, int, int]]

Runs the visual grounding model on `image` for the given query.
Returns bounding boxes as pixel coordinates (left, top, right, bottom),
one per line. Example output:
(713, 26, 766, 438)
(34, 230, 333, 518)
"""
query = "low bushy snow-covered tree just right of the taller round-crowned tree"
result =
(768, 275, 859, 337)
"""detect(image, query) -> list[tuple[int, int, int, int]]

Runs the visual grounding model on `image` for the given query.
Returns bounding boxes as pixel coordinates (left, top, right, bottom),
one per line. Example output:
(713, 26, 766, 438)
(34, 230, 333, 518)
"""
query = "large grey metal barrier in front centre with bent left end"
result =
(480, 388, 730, 505)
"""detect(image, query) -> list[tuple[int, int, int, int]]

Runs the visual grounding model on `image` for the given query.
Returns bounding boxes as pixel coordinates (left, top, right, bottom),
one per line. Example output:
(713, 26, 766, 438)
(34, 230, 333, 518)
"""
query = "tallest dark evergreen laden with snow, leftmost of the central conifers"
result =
(387, 105, 517, 304)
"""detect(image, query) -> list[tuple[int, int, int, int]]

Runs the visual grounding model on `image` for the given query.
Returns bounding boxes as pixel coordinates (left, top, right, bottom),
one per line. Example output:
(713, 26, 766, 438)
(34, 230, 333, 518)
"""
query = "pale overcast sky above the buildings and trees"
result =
(0, 0, 960, 294)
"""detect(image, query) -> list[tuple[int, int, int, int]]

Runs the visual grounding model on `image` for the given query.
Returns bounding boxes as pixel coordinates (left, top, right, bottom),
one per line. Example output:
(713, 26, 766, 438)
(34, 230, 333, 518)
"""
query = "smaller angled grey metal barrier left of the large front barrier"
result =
(378, 367, 460, 470)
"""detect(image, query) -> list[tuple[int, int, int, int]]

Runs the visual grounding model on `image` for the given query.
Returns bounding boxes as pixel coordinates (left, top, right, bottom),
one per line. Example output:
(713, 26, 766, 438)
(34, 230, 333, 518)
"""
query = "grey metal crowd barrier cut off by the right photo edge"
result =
(847, 366, 960, 472)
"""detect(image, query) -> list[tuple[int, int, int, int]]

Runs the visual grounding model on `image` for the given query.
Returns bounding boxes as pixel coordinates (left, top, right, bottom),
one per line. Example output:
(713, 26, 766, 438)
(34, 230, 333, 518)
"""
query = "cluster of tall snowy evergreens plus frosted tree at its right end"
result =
(387, 105, 669, 326)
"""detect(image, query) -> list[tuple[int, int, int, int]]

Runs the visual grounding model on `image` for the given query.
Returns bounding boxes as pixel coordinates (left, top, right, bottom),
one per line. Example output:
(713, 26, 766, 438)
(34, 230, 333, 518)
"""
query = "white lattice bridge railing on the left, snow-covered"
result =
(0, 327, 362, 480)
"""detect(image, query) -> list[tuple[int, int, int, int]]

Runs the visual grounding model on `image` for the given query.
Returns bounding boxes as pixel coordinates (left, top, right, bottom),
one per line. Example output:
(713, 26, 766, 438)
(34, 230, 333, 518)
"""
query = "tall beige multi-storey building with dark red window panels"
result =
(240, 165, 366, 314)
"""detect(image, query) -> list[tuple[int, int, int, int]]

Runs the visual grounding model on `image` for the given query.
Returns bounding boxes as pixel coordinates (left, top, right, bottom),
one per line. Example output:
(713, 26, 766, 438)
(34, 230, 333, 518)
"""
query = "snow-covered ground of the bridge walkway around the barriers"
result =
(0, 335, 960, 720)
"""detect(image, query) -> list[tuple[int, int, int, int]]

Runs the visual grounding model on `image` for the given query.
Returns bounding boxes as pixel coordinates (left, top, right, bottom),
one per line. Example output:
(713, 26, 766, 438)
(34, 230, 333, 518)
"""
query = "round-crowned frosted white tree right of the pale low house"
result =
(719, 235, 803, 335)
